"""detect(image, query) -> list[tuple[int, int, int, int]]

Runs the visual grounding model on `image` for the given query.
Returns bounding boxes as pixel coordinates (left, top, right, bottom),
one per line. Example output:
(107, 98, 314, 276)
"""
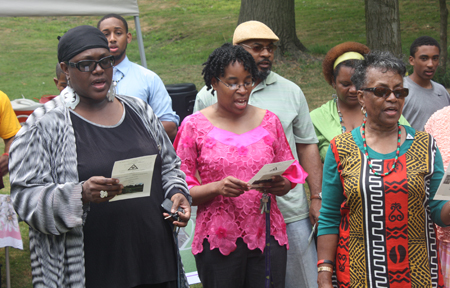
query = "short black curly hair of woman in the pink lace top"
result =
(202, 43, 258, 94)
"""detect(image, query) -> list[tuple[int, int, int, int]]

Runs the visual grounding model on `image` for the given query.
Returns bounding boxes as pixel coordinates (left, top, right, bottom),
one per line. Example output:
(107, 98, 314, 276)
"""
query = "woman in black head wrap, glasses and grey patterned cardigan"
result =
(10, 26, 191, 288)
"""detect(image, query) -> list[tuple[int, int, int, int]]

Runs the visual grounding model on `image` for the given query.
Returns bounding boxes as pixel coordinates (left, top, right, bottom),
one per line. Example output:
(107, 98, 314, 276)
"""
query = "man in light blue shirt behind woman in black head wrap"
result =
(97, 14, 180, 140)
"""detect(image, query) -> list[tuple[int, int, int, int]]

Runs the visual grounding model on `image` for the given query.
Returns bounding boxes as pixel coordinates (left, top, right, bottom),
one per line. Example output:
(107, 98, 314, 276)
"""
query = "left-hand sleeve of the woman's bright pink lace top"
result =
(173, 116, 200, 189)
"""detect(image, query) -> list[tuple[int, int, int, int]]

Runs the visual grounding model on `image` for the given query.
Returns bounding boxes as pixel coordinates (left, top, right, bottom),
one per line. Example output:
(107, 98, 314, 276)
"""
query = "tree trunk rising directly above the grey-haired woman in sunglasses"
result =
(365, 0, 402, 57)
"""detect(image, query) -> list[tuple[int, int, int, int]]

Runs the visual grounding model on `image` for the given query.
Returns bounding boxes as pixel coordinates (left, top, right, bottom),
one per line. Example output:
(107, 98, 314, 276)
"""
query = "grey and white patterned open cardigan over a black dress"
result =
(9, 96, 191, 288)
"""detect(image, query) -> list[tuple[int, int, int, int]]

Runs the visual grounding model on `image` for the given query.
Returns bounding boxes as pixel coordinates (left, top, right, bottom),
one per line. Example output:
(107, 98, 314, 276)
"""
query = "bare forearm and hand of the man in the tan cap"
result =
(295, 143, 322, 225)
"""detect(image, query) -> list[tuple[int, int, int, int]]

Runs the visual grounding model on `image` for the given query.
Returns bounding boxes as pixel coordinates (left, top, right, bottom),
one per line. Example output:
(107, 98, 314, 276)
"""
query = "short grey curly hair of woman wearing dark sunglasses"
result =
(352, 51, 406, 90)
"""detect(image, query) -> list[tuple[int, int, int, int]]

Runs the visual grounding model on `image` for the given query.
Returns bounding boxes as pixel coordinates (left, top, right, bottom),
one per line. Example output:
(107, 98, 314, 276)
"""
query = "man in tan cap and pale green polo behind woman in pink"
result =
(194, 21, 322, 288)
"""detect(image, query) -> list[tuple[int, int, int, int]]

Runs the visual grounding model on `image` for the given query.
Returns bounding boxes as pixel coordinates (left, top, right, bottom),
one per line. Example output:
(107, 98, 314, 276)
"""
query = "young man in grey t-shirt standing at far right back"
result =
(403, 36, 450, 131)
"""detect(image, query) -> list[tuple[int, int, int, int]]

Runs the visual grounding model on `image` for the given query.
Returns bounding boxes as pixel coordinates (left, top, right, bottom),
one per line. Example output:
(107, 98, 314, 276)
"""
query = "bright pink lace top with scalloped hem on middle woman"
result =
(174, 111, 308, 255)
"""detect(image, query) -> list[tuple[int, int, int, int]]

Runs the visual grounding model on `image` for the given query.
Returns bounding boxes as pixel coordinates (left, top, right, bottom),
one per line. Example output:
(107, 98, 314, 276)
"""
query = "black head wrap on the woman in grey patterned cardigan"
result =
(58, 25, 109, 62)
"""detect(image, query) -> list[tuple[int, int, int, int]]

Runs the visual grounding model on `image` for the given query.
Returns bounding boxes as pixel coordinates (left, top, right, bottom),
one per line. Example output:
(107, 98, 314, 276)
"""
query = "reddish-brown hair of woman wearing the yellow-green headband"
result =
(322, 42, 370, 85)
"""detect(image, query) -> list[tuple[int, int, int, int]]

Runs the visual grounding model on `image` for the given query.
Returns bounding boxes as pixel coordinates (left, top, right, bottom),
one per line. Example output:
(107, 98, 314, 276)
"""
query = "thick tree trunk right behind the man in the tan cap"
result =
(238, 0, 308, 58)
